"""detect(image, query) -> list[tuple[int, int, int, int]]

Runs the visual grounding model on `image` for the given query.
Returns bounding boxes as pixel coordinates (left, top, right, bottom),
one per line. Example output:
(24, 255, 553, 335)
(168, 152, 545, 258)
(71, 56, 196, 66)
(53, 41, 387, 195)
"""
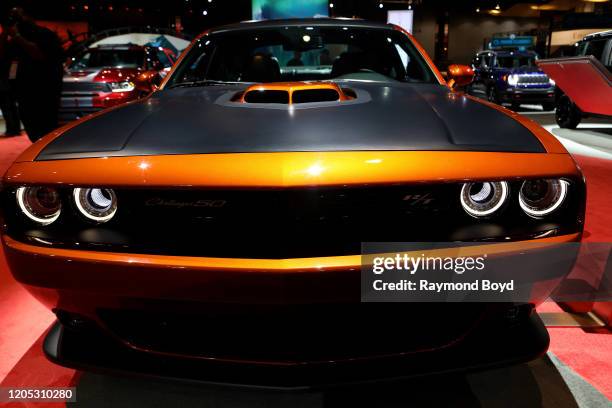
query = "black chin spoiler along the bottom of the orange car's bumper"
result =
(44, 313, 549, 390)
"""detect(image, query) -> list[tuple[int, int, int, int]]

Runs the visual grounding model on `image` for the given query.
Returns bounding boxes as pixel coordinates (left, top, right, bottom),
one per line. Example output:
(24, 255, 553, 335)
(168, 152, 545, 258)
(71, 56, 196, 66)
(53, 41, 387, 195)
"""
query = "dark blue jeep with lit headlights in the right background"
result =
(468, 50, 555, 111)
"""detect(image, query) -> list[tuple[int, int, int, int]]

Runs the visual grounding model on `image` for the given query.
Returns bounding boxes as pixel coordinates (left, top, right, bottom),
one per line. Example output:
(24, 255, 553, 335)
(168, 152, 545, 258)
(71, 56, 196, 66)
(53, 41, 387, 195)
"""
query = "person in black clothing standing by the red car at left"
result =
(0, 7, 64, 142)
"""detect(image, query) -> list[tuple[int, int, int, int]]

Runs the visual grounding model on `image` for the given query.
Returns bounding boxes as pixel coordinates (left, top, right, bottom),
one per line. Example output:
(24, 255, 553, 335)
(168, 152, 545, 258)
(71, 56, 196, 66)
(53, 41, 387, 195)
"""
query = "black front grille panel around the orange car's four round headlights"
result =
(4, 181, 584, 259)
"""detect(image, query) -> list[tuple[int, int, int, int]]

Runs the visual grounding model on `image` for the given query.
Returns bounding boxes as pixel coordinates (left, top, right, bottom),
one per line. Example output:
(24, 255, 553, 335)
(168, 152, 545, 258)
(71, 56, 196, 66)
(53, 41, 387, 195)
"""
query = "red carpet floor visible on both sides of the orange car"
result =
(0, 136, 612, 407)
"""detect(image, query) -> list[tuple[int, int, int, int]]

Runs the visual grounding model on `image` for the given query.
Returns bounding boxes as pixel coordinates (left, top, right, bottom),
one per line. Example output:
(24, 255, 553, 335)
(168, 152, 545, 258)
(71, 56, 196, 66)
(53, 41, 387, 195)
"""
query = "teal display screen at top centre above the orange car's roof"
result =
(253, 0, 329, 20)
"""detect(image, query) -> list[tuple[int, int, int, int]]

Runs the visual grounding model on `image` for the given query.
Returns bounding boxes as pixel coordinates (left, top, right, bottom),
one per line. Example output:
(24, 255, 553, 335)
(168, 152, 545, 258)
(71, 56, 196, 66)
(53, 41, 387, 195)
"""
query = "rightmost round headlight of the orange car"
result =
(519, 179, 569, 218)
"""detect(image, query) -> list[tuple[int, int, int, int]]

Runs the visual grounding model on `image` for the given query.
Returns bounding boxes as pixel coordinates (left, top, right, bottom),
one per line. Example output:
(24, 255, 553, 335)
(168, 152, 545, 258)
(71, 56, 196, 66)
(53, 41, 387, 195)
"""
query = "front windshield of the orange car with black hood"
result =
(168, 26, 435, 86)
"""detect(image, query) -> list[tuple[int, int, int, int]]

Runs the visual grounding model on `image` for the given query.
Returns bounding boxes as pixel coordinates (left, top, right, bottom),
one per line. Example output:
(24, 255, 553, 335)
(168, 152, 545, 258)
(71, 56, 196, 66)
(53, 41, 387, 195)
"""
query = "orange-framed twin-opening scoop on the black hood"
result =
(232, 82, 356, 105)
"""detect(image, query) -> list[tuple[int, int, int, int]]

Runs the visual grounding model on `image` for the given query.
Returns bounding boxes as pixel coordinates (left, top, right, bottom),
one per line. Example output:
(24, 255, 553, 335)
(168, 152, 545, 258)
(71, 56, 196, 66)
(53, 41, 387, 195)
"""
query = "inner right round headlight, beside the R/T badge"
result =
(461, 181, 508, 217)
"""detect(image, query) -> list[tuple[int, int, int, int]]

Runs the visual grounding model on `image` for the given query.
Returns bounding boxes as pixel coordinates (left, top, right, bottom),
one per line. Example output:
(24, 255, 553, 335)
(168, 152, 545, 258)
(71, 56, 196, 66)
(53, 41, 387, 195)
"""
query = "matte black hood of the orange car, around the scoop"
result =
(37, 82, 545, 160)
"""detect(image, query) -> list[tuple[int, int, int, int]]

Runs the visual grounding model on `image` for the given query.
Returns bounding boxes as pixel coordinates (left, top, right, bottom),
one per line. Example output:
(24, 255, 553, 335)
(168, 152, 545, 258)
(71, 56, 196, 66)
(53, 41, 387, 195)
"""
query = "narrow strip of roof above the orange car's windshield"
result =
(210, 18, 393, 34)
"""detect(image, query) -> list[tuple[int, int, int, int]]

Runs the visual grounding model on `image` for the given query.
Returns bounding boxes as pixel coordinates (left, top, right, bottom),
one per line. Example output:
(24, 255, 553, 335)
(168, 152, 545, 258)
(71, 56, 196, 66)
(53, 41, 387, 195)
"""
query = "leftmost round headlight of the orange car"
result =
(17, 187, 62, 225)
